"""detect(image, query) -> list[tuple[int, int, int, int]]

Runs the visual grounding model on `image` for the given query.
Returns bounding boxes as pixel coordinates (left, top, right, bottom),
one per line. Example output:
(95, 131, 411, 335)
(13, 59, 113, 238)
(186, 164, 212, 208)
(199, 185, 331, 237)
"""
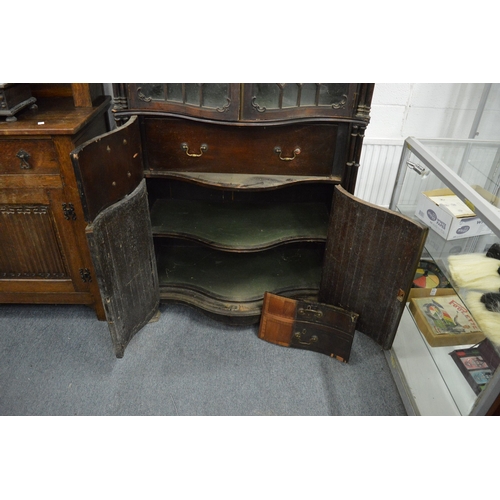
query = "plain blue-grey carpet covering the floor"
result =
(0, 304, 406, 416)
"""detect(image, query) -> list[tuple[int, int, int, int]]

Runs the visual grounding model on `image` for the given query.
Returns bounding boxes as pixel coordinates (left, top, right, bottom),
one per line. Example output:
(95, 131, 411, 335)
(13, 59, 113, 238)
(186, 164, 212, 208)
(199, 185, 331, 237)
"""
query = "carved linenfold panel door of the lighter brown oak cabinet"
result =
(0, 186, 88, 294)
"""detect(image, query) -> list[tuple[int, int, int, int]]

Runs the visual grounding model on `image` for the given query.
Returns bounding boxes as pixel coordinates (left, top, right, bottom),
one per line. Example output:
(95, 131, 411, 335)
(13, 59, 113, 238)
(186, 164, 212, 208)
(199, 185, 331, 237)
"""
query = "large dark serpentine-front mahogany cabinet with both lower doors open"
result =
(72, 83, 426, 357)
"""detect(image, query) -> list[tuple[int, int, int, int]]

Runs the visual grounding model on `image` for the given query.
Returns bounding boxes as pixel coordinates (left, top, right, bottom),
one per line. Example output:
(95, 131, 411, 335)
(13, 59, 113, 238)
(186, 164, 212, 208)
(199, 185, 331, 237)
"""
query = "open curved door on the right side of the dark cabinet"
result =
(319, 186, 428, 349)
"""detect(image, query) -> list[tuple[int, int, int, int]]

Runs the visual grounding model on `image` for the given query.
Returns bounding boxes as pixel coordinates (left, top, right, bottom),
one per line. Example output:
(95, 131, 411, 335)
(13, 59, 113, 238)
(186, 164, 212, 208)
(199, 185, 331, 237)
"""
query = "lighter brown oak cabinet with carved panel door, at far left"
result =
(0, 84, 110, 319)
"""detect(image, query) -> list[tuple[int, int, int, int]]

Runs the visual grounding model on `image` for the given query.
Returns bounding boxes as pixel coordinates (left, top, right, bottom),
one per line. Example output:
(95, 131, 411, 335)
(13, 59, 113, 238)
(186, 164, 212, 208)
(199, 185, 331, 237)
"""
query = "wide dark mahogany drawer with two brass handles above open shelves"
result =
(144, 118, 338, 176)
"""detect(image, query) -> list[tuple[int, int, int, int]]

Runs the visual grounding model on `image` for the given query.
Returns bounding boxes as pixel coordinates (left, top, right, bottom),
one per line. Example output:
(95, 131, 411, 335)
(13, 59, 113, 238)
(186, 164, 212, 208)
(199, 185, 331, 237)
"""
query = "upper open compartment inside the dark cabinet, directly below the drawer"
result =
(151, 199, 328, 252)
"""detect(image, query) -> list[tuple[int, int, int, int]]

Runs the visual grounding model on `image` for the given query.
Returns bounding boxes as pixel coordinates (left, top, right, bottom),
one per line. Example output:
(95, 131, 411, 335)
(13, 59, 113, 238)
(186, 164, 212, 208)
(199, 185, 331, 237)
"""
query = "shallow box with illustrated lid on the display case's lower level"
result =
(409, 288, 485, 347)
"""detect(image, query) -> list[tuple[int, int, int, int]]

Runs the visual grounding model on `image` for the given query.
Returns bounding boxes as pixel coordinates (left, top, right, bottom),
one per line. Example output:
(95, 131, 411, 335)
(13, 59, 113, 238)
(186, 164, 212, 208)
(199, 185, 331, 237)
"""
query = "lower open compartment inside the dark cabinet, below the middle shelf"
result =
(155, 238, 324, 315)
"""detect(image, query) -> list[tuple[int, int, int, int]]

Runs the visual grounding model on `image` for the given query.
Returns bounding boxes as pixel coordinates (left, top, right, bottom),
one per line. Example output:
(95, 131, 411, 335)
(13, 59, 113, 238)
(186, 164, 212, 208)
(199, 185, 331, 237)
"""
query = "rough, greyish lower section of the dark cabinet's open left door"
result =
(87, 180, 160, 358)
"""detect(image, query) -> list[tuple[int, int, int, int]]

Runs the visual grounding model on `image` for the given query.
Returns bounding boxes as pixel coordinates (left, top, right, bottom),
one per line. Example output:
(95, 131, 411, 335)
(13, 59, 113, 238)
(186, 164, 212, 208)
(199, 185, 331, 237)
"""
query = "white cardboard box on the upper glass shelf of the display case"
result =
(415, 188, 491, 240)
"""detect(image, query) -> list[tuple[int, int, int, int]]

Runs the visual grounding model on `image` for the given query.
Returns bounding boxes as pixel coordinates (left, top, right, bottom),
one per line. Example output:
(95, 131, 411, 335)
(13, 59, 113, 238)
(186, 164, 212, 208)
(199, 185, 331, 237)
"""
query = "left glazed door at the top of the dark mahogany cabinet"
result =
(126, 83, 240, 121)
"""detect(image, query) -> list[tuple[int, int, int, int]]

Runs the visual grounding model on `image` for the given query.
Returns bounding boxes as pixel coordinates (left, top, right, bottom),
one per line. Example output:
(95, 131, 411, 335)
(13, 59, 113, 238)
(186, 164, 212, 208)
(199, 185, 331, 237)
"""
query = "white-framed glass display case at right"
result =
(387, 137, 500, 415)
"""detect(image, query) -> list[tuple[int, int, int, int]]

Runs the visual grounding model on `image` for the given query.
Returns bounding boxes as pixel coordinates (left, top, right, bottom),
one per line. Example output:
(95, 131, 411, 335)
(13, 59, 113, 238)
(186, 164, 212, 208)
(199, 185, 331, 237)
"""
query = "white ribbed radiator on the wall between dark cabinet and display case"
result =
(354, 139, 404, 208)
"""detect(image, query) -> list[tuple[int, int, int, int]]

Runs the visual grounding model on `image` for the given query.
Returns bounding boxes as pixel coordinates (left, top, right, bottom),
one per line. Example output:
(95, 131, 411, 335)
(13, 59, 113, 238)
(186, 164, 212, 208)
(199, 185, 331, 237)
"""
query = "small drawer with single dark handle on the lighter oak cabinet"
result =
(0, 139, 59, 174)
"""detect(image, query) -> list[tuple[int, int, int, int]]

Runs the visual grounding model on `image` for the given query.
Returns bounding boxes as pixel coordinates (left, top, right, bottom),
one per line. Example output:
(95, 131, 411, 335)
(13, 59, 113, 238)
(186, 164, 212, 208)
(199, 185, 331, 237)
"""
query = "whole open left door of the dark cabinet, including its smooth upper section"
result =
(71, 117, 160, 358)
